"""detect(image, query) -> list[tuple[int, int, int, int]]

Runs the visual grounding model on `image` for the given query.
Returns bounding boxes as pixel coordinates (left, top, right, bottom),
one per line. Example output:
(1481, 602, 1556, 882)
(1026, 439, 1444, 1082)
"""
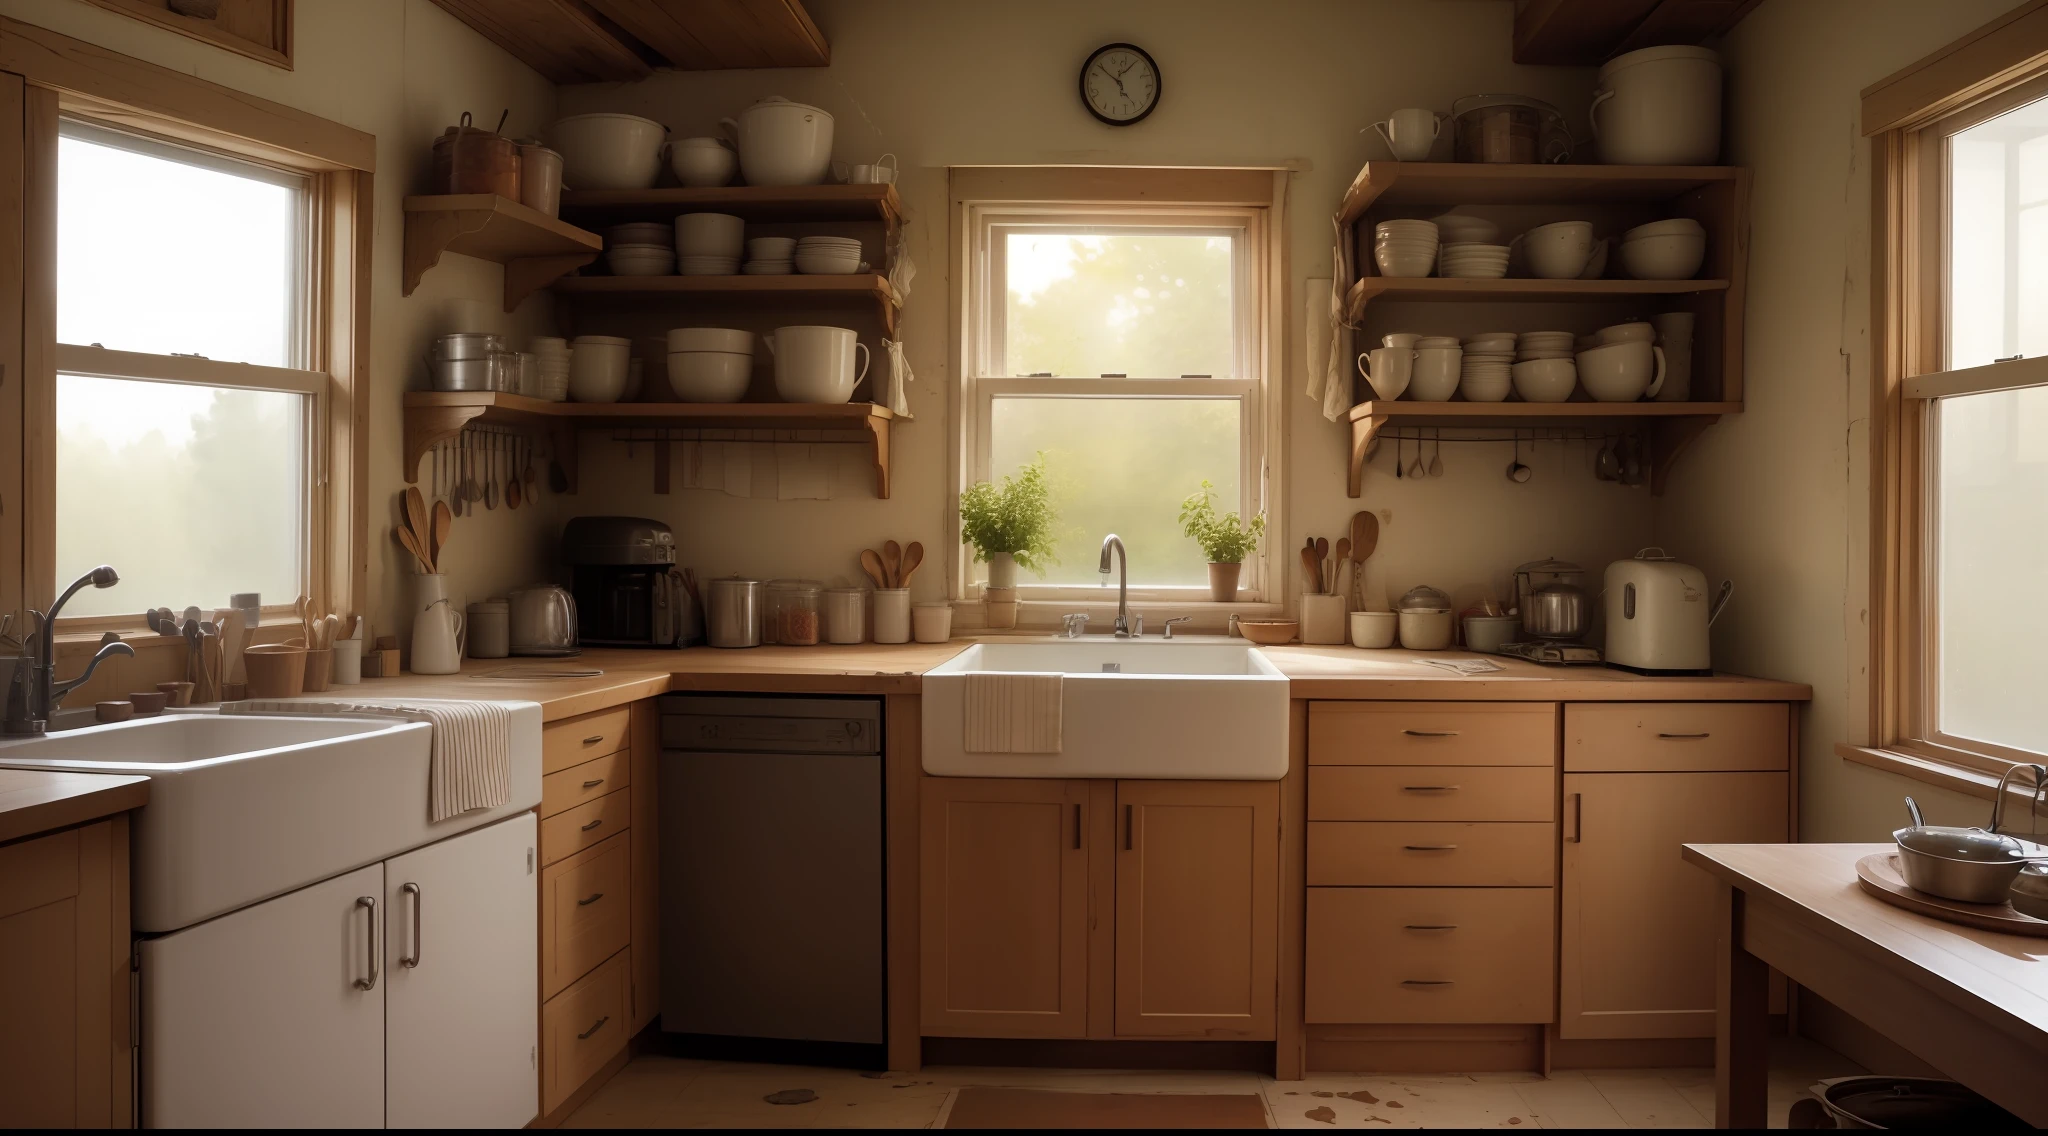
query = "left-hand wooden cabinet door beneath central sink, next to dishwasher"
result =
(920, 778, 1087, 1038)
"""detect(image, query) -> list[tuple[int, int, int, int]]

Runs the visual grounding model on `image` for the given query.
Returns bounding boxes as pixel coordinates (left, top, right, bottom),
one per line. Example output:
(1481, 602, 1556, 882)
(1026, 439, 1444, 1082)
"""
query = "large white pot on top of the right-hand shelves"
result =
(1589, 47, 1720, 166)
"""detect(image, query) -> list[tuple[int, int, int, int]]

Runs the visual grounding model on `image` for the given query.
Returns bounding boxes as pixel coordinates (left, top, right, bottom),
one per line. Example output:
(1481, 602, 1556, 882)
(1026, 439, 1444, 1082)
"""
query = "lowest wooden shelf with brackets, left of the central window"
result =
(406, 391, 895, 497)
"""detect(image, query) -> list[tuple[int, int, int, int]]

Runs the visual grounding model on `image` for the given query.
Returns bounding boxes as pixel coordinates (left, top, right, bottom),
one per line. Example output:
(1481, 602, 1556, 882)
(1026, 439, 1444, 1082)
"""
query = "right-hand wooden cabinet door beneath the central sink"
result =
(1116, 782, 1280, 1040)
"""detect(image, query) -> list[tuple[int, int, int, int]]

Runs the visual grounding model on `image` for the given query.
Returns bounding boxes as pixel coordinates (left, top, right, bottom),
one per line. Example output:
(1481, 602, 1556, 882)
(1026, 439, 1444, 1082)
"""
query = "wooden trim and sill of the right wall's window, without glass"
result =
(1837, 0, 2048, 781)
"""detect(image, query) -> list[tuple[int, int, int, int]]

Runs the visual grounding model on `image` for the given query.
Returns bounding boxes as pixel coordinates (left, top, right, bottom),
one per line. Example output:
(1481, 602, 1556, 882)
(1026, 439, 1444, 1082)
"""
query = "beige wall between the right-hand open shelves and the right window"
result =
(1657, 0, 2013, 841)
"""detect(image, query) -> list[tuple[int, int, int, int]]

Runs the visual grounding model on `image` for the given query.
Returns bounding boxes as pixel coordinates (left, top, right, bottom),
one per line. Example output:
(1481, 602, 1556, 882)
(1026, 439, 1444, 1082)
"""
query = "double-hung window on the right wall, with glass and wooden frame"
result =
(1864, 10, 2048, 778)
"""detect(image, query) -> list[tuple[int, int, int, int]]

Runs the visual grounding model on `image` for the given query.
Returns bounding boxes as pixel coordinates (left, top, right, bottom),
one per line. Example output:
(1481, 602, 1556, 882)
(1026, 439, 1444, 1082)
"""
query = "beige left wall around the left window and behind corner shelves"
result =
(0, 0, 555, 630)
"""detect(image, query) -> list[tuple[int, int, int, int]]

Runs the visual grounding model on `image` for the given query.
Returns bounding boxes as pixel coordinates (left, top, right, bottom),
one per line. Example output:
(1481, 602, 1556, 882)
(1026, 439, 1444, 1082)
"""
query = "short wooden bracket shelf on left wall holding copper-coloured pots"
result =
(401, 192, 604, 311)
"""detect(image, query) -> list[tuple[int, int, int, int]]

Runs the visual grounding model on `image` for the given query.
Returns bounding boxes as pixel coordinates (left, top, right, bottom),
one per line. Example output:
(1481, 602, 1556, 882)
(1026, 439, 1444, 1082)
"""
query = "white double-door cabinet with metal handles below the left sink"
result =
(137, 813, 541, 1128)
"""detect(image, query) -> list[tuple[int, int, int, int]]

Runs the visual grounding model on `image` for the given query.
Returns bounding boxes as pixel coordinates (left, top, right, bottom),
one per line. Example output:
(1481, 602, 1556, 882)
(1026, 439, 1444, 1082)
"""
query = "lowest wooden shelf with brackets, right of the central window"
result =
(1348, 401, 1743, 497)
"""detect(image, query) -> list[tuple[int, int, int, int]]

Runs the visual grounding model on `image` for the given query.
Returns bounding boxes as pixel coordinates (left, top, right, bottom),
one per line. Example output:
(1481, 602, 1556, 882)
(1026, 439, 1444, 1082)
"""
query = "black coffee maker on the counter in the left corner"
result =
(561, 516, 702, 649)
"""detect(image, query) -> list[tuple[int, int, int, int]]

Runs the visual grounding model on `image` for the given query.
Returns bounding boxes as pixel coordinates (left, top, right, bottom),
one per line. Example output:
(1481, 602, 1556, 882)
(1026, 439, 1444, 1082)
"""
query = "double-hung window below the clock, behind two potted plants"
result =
(954, 168, 1282, 604)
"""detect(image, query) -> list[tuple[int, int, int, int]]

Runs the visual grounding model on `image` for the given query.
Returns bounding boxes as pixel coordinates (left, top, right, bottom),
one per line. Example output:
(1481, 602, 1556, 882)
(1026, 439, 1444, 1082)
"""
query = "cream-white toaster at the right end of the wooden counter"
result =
(1604, 549, 1735, 675)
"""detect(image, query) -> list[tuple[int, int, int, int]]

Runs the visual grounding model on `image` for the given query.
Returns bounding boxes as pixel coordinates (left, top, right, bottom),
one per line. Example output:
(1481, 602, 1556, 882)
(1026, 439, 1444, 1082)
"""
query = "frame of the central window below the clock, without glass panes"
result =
(948, 166, 1286, 614)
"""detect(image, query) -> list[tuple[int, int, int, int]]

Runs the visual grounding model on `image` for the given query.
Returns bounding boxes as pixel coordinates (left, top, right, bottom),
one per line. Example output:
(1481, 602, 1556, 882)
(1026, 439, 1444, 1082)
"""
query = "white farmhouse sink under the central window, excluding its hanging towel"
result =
(924, 639, 1288, 780)
